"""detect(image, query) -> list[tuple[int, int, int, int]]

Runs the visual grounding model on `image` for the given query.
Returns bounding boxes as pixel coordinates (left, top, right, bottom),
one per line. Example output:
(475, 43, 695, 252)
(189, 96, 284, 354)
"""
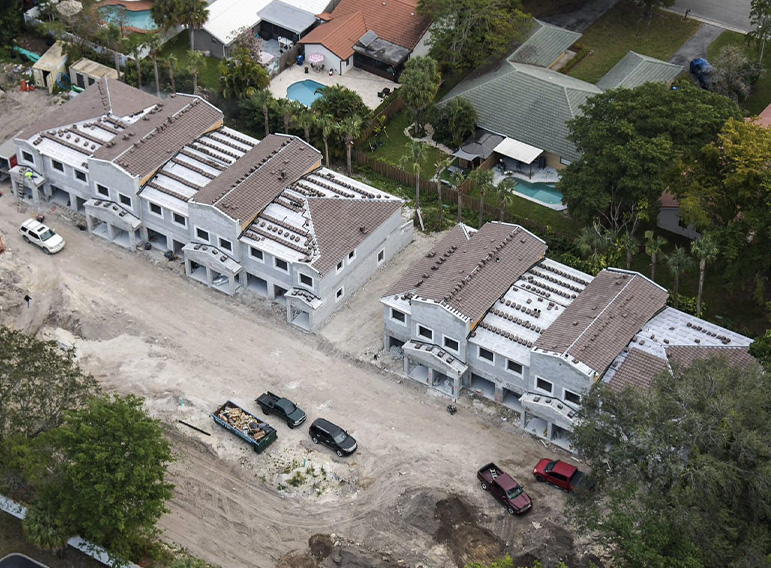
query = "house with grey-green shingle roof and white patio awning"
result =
(439, 20, 683, 170)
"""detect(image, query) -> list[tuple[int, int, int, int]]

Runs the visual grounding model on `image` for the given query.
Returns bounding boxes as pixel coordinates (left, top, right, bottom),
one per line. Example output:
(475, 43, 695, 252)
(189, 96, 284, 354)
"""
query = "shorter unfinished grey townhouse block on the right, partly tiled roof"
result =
(380, 222, 754, 449)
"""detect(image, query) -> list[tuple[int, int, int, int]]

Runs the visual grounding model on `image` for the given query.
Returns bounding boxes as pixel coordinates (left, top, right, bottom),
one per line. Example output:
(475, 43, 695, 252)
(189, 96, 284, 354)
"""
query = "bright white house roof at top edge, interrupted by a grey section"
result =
(203, 0, 330, 45)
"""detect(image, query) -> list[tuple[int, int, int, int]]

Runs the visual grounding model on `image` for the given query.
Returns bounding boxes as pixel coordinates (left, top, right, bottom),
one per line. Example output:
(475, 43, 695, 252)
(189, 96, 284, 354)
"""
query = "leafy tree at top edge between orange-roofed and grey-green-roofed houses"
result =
(418, 0, 533, 70)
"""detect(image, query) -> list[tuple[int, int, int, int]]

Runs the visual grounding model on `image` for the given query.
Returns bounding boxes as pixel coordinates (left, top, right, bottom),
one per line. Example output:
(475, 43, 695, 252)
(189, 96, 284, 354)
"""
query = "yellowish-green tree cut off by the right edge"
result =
(672, 120, 771, 288)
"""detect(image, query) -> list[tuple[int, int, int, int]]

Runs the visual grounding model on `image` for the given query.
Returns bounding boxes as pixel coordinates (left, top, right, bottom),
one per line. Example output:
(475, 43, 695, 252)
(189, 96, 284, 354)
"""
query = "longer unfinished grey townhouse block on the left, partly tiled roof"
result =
(12, 79, 413, 331)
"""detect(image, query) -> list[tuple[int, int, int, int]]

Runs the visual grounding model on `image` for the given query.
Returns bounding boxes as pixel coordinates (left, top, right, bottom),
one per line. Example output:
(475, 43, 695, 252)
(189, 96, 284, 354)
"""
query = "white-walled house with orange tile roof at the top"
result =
(300, 0, 431, 81)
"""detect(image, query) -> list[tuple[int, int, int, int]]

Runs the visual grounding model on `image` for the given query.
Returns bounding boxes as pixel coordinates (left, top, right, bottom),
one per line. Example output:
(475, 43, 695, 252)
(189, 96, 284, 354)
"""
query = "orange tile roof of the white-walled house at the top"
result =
(300, 0, 431, 55)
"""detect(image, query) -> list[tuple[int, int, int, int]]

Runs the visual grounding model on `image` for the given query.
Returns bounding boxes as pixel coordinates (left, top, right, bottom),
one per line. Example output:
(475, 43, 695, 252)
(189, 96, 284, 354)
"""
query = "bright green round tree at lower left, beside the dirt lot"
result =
(38, 395, 173, 558)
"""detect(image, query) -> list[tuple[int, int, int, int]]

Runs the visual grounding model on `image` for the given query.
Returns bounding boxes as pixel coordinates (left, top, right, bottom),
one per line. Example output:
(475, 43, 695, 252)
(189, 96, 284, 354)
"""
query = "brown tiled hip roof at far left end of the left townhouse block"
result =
(17, 78, 161, 140)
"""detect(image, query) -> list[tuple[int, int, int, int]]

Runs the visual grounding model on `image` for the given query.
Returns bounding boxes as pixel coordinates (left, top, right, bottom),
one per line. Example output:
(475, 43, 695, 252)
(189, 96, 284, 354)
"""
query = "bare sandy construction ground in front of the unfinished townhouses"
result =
(0, 86, 601, 568)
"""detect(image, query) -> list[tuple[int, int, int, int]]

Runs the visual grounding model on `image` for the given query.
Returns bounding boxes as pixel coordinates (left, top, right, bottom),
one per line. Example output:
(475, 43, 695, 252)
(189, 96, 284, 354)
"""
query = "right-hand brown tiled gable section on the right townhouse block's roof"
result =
(535, 270, 668, 373)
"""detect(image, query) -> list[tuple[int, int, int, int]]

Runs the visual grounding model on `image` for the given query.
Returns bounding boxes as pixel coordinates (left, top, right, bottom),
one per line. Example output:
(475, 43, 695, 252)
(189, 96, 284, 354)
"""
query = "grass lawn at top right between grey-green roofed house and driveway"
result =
(569, 0, 699, 83)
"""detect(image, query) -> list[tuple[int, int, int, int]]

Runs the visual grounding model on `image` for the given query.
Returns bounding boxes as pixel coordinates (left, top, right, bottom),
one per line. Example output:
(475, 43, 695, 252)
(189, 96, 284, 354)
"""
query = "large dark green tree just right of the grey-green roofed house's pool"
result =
(559, 82, 742, 235)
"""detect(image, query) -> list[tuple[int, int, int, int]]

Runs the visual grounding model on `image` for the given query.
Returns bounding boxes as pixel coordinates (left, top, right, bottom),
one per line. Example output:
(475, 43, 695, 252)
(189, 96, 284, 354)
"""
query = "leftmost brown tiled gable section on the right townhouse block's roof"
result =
(388, 223, 546, 325)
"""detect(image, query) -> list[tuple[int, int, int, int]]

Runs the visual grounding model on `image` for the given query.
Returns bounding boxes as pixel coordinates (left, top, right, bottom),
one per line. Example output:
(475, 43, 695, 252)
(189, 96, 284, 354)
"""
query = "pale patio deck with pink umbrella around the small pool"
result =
(270, 63, 399, 109)
